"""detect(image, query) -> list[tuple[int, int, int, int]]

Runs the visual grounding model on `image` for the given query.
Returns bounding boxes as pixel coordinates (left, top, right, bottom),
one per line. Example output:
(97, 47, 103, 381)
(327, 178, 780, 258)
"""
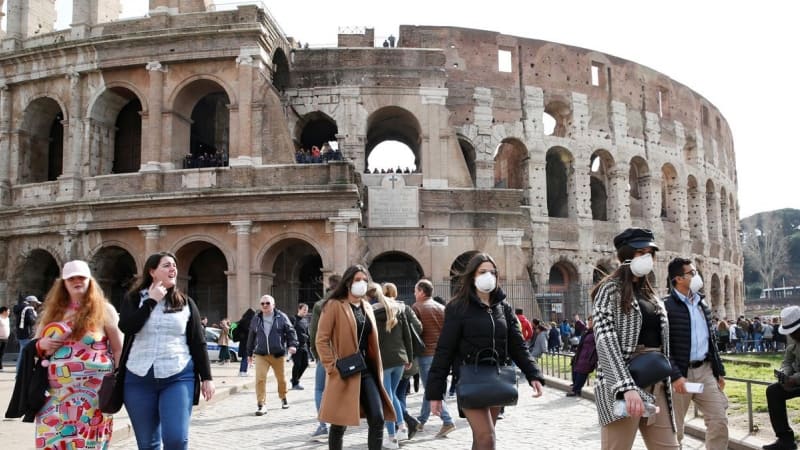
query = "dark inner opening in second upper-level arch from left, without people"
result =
(111, 98, 142, 173)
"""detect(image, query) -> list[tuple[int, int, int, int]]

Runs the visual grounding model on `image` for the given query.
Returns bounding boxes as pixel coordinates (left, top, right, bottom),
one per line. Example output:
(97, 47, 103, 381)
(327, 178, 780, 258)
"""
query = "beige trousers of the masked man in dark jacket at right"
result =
(672, 361, 728, 450)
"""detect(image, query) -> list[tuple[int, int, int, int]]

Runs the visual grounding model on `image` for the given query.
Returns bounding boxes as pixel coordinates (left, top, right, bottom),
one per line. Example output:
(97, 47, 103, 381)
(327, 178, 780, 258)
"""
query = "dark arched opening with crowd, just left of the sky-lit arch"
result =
(295, 111, 342, 163)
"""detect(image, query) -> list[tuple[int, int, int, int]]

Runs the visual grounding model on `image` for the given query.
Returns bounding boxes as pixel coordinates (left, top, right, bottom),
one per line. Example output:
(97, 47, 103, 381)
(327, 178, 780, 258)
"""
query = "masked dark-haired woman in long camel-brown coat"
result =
(315, 265, 396, 450)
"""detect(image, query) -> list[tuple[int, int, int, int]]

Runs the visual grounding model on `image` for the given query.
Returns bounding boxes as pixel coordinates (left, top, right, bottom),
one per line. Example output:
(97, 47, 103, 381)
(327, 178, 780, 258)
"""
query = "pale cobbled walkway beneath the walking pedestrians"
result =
(0, 363, 771, 450)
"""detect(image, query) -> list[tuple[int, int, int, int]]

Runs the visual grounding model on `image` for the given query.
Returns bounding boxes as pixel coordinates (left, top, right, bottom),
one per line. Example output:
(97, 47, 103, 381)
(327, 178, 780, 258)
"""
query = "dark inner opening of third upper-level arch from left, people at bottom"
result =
(187, 92, 230, 167)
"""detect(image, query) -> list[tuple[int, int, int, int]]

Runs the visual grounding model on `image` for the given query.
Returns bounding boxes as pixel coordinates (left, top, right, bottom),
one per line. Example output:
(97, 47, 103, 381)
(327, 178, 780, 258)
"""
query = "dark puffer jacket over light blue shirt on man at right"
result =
(664, 289, 725, 381)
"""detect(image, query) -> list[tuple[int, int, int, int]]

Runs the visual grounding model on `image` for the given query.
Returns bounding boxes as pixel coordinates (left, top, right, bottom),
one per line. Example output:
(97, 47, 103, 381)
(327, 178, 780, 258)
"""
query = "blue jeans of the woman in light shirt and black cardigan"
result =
(124, 359, 195, 450)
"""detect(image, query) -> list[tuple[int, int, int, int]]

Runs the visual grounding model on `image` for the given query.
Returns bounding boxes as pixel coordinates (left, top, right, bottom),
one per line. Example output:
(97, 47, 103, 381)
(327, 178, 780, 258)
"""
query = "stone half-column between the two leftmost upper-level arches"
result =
(58, 70, 83, 201)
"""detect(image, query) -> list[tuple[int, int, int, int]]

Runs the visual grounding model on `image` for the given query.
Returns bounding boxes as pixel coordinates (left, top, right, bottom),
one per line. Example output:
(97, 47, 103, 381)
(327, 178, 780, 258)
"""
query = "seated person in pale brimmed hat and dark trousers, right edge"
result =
(762, 306, 800, 450)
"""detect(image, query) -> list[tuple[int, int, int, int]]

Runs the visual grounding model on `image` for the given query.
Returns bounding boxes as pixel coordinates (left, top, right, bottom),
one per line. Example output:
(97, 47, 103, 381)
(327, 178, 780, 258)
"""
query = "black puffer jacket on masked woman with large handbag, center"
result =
(425, 289, 544, 400)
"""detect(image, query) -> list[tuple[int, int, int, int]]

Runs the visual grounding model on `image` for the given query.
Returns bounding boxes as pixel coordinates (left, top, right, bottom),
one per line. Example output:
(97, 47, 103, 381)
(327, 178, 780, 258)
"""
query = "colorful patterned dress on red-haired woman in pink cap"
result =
(36, 322, 114, 450)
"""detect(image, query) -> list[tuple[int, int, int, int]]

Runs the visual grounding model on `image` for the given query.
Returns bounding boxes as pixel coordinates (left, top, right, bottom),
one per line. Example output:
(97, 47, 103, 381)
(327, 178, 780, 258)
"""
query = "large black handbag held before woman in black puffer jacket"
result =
(456, 348, 519, 409)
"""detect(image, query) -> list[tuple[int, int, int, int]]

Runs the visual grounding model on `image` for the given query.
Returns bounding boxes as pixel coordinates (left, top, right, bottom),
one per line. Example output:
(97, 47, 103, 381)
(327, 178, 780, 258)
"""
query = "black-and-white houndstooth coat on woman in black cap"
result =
(592, 279, 675, 430)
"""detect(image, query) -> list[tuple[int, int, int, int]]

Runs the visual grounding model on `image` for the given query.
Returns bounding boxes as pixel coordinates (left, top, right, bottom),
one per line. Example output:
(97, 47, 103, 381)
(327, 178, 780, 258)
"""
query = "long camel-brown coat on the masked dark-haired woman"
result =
(316, 299, 397, 426)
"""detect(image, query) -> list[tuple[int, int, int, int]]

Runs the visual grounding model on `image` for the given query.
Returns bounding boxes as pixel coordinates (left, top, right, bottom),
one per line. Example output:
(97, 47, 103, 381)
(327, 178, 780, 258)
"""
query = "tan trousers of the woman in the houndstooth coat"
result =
(600, 382, 680, 450)
